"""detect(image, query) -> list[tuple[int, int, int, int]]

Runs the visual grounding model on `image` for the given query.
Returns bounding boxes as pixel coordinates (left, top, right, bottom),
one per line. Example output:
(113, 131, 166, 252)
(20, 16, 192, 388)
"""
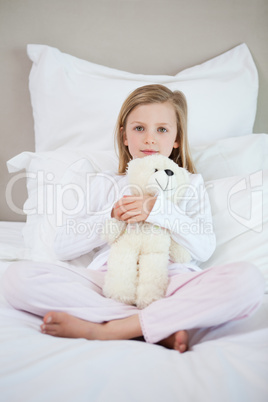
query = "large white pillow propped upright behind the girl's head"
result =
(27, 44, 258, 152)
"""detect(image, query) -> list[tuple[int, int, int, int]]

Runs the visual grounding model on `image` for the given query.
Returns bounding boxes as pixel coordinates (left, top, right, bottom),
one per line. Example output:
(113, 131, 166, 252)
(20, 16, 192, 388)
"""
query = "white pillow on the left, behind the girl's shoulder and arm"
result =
(7, 149, 118, 263)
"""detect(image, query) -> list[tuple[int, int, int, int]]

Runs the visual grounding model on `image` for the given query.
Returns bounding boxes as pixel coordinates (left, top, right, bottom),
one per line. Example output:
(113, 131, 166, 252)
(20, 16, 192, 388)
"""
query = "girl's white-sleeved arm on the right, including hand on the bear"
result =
(108, 175, 216, 261)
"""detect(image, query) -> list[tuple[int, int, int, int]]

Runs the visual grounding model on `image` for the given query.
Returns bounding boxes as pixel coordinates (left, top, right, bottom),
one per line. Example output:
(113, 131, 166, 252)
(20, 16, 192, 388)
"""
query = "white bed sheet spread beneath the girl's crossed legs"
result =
(0, 222, 268, 402)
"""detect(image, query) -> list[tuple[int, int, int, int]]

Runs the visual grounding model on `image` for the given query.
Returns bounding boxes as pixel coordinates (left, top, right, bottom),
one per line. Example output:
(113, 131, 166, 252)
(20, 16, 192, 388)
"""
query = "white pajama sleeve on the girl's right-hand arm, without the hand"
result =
(147, 175, 216, 262)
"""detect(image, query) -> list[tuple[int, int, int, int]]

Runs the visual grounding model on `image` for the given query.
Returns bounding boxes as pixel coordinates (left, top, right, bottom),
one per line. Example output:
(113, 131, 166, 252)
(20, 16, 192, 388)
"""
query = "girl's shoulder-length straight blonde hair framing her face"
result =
(115, 84, 196, 174)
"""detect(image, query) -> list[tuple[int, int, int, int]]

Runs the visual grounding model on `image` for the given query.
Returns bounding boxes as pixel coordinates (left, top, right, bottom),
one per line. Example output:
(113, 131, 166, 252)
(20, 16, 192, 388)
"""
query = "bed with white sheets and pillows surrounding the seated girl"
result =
(0, 44, 268, 402)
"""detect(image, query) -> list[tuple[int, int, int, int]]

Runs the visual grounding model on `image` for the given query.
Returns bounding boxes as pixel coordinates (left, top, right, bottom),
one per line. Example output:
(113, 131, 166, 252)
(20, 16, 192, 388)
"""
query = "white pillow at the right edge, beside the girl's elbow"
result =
(201, 170, 268, 292)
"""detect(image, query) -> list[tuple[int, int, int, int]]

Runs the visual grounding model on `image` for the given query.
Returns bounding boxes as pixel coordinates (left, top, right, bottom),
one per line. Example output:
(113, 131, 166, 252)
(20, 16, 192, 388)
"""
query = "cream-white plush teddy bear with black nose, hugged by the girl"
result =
(103, 155, 191, 309)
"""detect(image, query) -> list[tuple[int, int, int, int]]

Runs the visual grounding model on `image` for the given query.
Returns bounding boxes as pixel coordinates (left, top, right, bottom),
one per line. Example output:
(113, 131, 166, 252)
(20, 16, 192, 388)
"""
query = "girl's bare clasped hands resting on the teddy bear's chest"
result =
(112, 195, 156, 223)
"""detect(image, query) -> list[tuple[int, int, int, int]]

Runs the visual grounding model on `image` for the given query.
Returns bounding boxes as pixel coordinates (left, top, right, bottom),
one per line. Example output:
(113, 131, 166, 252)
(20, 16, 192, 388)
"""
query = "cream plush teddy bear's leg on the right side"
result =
(136, 231, 170, 308)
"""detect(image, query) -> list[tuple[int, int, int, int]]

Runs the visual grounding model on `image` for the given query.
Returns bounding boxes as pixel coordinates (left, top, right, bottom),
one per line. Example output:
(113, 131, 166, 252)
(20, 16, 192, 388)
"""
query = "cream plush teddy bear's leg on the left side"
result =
(103, 233, 140, 304)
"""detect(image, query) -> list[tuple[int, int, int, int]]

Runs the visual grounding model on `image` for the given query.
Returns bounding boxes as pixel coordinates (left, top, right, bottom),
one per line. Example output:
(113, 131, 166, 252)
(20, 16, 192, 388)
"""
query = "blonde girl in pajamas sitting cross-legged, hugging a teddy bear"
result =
(4, 85, 264, 352)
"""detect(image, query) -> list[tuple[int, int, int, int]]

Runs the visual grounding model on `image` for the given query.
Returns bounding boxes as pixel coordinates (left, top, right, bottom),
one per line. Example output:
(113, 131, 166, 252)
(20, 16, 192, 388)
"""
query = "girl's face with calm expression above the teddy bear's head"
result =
(123, 102, 179, 159)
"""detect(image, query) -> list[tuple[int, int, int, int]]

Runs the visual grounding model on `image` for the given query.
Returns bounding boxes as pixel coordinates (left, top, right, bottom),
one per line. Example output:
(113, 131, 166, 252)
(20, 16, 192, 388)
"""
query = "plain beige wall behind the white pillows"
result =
(0, 0, 268, 220)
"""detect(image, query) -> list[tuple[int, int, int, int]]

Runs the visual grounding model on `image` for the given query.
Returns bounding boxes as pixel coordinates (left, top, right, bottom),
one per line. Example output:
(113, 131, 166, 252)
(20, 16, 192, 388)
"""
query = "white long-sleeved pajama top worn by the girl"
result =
(54, 172, 216, 270)
